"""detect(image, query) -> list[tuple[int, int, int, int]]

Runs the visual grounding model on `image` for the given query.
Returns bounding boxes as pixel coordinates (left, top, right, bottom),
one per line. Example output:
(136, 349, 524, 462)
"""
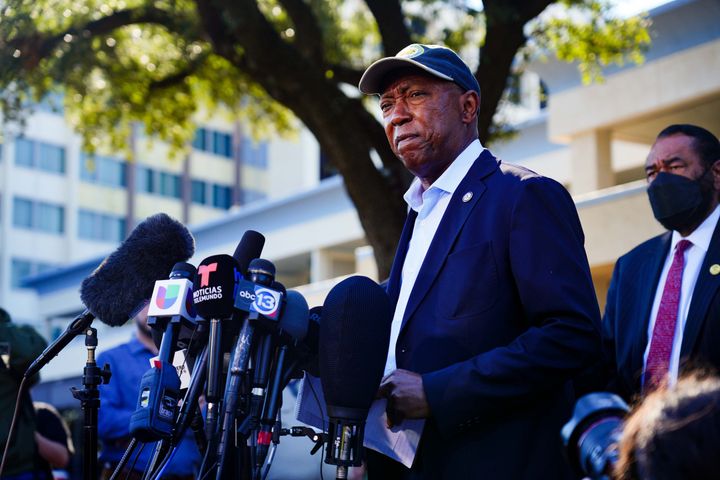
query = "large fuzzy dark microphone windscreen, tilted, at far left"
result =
(80, 213, 195, 327)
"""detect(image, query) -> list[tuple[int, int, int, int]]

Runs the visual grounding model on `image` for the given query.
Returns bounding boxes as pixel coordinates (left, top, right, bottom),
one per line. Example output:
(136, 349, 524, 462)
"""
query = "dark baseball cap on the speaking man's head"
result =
(358, 43, 480, 95)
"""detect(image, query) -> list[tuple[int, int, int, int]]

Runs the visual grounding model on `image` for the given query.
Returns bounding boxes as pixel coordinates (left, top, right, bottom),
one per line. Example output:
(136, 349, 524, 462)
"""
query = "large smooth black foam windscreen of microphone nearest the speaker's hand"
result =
(318, 276, 393, 414)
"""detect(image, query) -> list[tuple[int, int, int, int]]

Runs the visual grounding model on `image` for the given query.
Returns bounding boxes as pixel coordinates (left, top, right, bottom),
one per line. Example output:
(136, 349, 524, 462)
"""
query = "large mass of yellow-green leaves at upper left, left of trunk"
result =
(0, 0, 296, 158)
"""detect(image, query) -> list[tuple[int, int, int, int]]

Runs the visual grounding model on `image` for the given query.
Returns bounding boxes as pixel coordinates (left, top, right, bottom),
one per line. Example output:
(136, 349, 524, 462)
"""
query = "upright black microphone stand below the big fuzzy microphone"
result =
(70, 327, 111, 479)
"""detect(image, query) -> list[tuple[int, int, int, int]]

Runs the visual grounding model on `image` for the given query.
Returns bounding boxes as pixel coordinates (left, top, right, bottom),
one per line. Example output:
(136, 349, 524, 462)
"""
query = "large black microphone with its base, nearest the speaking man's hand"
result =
(319, 276, 393, 479)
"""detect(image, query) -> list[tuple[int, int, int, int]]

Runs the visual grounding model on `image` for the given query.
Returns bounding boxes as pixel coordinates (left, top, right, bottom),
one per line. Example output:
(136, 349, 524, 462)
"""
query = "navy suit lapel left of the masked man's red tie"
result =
(628, 232, 672, 381)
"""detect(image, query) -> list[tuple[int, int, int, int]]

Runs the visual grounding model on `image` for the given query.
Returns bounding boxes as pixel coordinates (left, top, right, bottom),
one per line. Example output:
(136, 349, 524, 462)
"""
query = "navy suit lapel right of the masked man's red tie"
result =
(680, 222, 720, 358)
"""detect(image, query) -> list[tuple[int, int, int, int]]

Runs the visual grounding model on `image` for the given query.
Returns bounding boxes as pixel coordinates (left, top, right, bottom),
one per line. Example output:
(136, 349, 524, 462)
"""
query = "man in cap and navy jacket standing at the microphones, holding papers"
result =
(359, 44, 600, 480)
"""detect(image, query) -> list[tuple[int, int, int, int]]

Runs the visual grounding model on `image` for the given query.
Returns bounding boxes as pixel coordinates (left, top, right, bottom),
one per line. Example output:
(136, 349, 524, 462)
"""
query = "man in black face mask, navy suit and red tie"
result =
(602, 125, 720, 401)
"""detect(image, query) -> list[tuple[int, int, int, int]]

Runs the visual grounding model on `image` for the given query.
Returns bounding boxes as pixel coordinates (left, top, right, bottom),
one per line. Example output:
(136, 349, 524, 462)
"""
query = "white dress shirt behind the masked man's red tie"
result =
(643, 206, 720, 385)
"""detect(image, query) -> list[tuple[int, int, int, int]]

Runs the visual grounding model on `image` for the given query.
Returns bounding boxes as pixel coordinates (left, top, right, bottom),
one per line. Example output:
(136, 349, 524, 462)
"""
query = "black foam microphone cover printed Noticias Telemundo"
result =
(193, 254, 240, 319)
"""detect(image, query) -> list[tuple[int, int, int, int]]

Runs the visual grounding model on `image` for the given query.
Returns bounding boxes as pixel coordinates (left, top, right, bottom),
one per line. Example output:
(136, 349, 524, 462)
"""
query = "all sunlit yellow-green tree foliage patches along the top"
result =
(0, 0, 649, 154)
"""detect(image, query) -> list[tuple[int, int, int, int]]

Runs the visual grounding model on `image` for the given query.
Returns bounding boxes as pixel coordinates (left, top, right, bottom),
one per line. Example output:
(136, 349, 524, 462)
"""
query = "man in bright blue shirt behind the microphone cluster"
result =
(97, 303, 201, 480)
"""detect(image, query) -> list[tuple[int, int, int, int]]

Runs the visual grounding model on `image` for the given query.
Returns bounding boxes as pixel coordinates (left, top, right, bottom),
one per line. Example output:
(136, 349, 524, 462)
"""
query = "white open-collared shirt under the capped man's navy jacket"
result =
(385, 140, 483, 375)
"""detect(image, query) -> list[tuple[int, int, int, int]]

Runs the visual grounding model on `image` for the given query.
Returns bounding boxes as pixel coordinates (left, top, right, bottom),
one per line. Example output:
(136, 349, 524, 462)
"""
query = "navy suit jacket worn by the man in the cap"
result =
(388, 150, 600, 480)
